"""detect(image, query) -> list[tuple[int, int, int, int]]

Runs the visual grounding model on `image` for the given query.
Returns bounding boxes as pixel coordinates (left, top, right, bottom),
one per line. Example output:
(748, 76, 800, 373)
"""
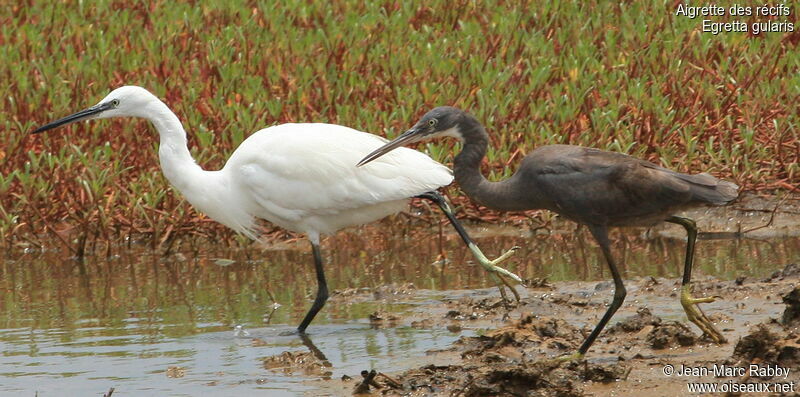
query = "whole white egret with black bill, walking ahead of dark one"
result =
(33, 86, 521, 333)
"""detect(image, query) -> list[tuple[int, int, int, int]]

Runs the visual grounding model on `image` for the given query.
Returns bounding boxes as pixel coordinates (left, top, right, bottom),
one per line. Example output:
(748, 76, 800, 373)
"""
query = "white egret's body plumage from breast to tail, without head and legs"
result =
(166, 120, 453, 238)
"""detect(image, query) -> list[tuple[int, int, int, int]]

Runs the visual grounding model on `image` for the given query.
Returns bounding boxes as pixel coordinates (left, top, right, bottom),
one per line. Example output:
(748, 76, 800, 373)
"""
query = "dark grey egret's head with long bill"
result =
(358, 106, 471, 167)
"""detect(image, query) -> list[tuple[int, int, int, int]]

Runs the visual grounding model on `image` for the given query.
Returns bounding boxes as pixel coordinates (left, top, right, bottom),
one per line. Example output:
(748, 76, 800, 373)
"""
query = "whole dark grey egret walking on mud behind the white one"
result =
(358, 106, 739, 357)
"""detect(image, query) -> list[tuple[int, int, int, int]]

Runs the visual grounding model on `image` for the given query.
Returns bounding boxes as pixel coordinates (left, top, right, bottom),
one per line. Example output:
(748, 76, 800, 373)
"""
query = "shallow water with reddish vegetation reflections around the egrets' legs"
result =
(0, 221, 800, 396)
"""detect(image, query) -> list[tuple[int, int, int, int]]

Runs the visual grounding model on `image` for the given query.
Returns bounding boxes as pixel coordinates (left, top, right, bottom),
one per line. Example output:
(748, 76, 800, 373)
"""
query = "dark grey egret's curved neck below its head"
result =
(453, 114, 542, 211)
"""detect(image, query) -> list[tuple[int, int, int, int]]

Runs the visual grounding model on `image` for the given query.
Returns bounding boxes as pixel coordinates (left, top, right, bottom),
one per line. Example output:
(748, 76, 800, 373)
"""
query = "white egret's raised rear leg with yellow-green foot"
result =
(417, 191, 522, 302)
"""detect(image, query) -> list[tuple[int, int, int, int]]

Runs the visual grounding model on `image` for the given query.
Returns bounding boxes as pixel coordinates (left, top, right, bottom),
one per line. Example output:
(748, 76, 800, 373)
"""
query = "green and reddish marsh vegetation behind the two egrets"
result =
(0, 0, 800, 248)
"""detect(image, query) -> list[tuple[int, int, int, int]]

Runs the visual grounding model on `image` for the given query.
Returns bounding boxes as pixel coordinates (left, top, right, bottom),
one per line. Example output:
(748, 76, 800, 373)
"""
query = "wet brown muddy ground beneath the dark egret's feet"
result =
(265, 264, 800, 396)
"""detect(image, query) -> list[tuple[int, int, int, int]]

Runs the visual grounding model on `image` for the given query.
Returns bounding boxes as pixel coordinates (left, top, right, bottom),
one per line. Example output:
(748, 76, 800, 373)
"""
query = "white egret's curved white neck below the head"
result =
(146, 99, 207, 194)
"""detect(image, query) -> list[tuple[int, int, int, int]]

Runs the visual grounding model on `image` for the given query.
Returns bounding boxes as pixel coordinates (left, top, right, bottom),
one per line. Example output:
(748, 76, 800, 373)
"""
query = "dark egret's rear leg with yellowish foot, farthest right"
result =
(667, 216, 727, 343)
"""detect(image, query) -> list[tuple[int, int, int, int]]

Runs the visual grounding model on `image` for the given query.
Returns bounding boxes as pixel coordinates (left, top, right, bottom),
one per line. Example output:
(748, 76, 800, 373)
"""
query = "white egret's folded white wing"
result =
(225, 124, 453, 221)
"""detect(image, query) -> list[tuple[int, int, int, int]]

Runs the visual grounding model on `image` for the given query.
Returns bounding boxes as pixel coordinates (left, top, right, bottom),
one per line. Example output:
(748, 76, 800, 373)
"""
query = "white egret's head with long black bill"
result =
(31, 85, 158, 134)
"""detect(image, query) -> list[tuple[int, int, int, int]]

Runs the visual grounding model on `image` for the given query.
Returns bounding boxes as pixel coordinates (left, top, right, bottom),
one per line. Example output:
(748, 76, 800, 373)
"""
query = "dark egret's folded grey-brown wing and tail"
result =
(521, 145, 735, 225)
